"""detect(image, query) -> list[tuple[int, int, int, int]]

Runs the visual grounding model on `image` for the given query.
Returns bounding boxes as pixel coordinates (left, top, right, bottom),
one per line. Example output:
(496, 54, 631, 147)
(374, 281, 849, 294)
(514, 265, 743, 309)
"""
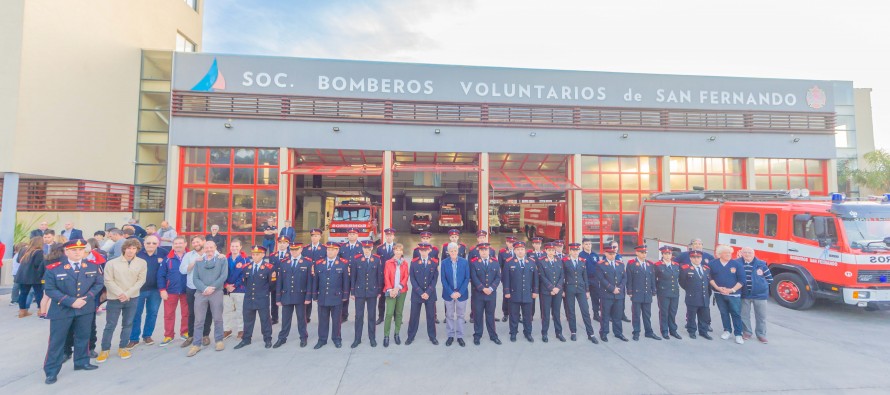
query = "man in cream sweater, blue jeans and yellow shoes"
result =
(96, 239, 148, 363)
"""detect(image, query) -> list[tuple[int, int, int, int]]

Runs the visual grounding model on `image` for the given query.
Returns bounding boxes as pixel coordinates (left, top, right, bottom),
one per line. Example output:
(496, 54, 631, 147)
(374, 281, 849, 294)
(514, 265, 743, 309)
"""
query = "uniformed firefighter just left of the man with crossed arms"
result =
(680, 254, 711, 340)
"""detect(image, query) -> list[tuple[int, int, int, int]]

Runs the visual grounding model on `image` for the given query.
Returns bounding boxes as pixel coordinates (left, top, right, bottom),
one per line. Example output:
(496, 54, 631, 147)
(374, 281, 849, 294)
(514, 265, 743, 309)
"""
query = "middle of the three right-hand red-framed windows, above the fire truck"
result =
(670, 157, 745, 191)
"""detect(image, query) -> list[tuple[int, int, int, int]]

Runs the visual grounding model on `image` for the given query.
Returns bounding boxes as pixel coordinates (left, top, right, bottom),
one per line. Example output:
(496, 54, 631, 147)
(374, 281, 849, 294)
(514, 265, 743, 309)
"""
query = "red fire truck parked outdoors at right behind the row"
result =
(640, 191, 890, 310)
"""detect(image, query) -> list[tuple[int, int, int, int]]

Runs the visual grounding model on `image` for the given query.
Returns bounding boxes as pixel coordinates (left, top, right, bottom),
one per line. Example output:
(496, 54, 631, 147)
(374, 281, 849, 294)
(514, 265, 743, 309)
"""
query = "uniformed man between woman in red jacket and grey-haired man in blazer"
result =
(405, 243, 439, 346)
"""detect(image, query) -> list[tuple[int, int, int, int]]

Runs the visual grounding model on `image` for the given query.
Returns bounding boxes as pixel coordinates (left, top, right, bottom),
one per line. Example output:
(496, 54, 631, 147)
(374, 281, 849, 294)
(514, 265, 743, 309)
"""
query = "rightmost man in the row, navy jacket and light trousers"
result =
(736, 247, 773, 344)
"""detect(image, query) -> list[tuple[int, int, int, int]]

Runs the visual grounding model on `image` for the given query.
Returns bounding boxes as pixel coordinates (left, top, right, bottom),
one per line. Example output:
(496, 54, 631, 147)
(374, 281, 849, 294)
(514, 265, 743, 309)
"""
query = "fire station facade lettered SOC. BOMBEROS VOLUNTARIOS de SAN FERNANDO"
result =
(166, 53, 852, 251)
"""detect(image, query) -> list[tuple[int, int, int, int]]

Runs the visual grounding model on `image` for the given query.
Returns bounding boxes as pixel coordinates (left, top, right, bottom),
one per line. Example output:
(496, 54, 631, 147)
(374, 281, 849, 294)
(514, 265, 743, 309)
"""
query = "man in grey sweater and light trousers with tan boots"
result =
(187, 241, 227, 357)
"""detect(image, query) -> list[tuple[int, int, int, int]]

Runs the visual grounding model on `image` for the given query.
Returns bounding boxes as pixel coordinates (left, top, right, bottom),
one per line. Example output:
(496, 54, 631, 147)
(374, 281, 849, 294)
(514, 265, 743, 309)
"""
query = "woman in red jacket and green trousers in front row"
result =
(383, 243, 408, 347)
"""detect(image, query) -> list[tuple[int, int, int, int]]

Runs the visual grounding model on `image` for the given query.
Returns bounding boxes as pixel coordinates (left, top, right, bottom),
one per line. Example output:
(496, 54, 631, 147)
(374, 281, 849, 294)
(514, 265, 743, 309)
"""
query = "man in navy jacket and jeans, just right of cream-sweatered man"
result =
(127, 235, 167, 349)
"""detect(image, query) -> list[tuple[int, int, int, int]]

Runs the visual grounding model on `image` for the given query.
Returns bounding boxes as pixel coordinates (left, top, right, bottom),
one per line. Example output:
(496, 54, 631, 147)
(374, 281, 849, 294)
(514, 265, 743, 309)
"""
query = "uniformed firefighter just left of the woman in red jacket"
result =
(349, 240, 383, 348)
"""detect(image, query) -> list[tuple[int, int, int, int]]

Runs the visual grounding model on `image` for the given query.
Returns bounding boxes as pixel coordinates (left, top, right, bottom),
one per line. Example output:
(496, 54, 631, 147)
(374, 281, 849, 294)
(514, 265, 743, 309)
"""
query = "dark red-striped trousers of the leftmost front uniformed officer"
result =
(43, 313, 96, 376)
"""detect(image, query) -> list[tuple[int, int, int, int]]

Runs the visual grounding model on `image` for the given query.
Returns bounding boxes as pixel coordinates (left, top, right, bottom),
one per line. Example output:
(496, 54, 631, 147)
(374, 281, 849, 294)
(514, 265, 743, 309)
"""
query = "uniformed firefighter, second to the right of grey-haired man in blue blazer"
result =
(501, 241, 539, 343)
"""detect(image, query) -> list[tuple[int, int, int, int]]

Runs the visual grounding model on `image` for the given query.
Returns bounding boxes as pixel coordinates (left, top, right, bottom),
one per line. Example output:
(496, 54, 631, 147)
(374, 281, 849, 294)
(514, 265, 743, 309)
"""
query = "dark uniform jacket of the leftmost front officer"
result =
(43, 257, 104, 320)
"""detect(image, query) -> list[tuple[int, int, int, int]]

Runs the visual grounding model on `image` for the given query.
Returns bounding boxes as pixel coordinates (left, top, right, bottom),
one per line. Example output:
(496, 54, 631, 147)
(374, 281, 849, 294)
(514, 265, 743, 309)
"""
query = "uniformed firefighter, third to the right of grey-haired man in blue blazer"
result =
(538, 243, 566, 343)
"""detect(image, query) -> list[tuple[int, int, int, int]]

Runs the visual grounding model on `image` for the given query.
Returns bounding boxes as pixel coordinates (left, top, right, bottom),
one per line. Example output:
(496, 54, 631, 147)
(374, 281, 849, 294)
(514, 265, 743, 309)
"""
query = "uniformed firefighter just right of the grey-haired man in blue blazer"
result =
(470, 243, 500, 346)
